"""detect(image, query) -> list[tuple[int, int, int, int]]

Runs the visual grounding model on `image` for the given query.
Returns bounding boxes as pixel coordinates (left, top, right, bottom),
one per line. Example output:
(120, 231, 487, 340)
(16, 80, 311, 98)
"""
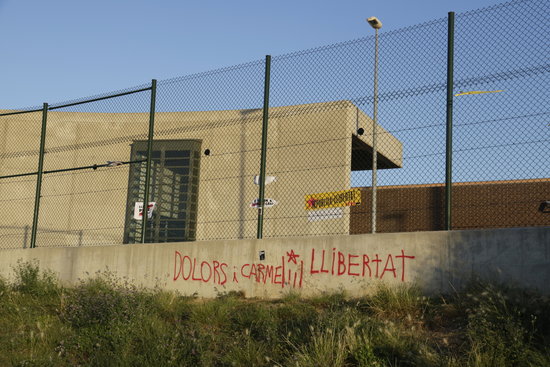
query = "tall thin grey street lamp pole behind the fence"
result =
(367, 17, 382, 233)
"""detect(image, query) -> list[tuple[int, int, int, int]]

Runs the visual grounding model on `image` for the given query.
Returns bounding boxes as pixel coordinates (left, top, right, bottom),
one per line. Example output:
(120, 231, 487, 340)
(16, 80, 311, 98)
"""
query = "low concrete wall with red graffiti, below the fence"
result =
(0, 227, 550, 298)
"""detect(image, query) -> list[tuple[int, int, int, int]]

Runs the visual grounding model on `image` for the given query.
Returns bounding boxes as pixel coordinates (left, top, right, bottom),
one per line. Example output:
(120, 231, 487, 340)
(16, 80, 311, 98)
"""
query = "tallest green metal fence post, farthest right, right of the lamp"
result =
(445, 11, 455, 231)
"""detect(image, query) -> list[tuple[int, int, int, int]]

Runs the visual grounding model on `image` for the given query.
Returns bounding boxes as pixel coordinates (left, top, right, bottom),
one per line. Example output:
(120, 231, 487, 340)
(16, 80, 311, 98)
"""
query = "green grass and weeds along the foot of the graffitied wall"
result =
(0, 263, 550, 367)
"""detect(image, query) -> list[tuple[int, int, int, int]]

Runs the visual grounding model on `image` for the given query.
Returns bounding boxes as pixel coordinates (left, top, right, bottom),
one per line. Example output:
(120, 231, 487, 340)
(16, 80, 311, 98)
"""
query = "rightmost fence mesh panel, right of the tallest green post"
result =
(453, 0, 550, 229)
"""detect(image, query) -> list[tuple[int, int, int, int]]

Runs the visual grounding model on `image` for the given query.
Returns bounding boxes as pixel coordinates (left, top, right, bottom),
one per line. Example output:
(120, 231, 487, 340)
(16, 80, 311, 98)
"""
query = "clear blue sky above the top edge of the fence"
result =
(0, 0, 508, 109)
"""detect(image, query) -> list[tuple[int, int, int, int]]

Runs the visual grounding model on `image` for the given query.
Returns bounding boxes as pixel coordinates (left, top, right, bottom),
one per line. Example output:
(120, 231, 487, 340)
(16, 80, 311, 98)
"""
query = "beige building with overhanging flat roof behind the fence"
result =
(0, 101, 402, 247)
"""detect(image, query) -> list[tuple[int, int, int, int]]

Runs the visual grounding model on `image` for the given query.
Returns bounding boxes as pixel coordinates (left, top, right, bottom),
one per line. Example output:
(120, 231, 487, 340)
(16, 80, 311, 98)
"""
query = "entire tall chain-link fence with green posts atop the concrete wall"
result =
(0, 0, 550, 248)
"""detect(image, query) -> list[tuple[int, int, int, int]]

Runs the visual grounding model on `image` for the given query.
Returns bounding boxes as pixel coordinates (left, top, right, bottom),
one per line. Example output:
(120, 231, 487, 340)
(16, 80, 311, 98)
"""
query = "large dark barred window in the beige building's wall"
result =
(124, 140, 201, 243)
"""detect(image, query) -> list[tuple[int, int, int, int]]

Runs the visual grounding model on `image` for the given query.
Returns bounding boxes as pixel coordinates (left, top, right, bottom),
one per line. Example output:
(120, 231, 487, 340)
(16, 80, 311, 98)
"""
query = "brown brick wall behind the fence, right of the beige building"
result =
(350, 179, 550, 234)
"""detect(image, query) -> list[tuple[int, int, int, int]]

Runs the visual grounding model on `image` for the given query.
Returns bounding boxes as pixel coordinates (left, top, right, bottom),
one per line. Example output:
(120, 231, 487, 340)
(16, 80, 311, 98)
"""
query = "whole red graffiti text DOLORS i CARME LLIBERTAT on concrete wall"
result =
(173, 248, 415, 288)
